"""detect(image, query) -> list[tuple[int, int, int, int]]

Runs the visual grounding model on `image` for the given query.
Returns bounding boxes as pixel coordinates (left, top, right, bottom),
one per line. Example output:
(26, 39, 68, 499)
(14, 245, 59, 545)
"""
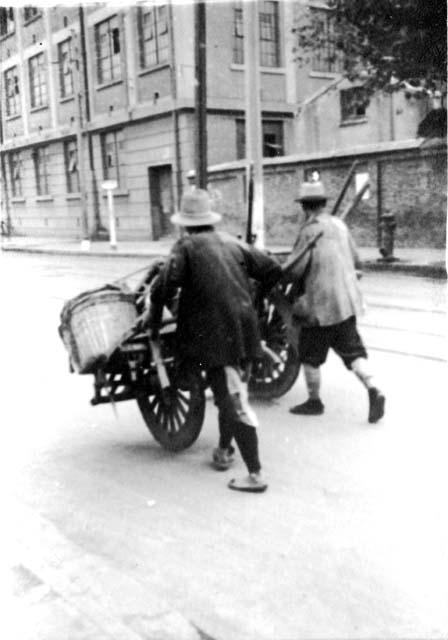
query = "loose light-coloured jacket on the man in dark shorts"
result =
(289, 213, 362, 327)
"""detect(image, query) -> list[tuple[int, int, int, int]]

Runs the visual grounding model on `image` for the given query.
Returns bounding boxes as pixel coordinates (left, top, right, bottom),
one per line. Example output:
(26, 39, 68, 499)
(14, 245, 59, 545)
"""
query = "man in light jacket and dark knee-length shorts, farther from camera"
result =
(284, 180, 385, 423)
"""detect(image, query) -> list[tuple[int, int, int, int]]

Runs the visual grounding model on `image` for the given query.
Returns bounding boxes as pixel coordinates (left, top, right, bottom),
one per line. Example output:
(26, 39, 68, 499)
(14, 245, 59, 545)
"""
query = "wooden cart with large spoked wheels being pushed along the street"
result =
(60, 265, 299, 451)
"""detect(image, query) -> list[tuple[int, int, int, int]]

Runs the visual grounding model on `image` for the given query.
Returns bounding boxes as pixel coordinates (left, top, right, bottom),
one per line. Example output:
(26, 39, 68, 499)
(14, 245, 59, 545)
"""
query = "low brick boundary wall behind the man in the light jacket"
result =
(205, 141, 446, 248)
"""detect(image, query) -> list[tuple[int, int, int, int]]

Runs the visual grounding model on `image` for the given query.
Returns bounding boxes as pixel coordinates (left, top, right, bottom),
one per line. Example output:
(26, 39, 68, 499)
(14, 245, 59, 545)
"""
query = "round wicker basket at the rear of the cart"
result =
(59, 285, 137, 373)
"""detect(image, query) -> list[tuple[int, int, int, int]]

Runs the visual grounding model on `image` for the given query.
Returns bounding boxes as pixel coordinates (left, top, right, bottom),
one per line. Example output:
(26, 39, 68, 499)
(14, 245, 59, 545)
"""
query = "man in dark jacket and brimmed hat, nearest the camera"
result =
(150, 189, 281, 492)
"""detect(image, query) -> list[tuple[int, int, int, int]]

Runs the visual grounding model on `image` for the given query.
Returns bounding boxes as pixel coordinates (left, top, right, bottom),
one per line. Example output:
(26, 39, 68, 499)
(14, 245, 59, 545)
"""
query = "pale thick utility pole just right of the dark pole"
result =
(243, 0, 264, 249)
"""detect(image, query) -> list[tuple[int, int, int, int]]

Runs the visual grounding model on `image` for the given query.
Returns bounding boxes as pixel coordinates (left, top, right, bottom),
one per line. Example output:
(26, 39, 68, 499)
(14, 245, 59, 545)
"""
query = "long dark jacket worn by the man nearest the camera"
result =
(151, 230, 281, 368)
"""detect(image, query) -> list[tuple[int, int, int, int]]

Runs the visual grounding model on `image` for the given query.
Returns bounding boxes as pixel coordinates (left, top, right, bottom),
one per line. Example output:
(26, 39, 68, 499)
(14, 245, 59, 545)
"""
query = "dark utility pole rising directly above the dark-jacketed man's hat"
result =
(194, 0, 208, 189)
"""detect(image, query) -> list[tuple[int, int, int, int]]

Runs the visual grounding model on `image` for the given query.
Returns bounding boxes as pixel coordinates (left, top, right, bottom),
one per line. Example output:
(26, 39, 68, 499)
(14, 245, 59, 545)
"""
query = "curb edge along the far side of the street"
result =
(1, 245, 447, 280)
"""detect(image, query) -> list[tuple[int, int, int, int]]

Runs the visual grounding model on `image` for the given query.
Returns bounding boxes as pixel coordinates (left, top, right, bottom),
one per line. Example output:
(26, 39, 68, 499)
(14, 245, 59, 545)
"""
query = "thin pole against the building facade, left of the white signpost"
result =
(72, 30, 90, 251)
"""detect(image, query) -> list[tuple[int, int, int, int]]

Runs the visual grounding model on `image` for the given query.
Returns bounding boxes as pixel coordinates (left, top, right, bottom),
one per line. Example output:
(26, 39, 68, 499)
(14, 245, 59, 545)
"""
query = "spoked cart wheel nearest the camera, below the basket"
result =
(137, 377, 205, 451)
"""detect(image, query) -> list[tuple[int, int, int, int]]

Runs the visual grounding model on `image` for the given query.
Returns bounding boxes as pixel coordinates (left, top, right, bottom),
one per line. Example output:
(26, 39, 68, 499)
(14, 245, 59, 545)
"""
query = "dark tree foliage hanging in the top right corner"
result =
(293, 0, 447, 93)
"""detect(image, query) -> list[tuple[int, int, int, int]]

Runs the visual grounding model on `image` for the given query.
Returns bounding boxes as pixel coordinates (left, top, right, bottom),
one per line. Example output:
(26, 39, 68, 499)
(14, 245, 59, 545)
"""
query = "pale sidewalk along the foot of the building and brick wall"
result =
(1, 232, 447, 279)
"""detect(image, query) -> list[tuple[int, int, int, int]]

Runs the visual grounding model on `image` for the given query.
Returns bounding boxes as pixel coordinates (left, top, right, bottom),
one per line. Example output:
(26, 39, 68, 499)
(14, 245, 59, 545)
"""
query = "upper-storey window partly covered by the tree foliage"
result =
(311, 8, 343, 73)
